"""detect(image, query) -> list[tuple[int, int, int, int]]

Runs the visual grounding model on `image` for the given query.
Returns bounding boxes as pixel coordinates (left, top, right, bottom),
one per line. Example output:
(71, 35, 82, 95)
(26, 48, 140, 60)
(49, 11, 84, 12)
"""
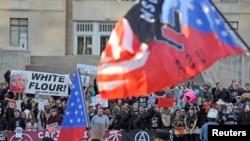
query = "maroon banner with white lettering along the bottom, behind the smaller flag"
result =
(6, 130, 122, 141)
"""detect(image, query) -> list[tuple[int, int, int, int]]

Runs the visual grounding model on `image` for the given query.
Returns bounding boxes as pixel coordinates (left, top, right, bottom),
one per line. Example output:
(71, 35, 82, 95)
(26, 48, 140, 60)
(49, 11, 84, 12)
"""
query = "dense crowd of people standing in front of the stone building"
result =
(0, 77, 250, 141)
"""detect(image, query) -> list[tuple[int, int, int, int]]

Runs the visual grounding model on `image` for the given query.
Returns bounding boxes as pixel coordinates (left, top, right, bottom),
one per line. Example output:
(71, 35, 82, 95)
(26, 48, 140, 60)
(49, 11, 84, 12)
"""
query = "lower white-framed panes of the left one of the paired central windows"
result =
(77, 36, 92, 55)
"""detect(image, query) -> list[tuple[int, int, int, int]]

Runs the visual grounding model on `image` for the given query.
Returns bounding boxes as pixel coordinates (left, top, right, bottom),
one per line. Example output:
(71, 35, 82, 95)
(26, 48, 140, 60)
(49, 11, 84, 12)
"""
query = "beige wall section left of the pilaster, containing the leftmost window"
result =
(0, 0, 66, 56)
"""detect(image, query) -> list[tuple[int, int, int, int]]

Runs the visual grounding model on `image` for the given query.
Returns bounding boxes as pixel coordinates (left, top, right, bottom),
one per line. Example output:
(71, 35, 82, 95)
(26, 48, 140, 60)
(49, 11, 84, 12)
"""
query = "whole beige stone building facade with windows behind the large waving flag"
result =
(0, 0, 250, 85)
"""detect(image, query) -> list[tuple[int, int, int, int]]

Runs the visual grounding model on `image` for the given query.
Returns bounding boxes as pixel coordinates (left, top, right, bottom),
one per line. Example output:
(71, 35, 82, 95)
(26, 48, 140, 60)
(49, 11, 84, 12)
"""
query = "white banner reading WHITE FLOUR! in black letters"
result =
(10, 70, 69, 96)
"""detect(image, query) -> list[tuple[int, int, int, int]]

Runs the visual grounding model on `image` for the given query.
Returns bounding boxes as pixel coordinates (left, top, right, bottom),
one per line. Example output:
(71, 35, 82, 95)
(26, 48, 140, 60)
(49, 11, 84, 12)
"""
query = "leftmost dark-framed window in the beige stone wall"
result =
(10, 18, 28, 46)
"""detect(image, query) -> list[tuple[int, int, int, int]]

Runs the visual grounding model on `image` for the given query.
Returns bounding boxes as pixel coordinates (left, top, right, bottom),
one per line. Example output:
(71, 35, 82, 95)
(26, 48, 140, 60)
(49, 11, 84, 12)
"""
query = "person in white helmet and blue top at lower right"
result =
(200, 108, 219, 141)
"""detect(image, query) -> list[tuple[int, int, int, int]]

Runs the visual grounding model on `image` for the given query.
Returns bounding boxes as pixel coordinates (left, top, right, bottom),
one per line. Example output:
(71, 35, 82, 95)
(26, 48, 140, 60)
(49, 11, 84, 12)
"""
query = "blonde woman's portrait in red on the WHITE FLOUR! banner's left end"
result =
(10, 73, 28, 93)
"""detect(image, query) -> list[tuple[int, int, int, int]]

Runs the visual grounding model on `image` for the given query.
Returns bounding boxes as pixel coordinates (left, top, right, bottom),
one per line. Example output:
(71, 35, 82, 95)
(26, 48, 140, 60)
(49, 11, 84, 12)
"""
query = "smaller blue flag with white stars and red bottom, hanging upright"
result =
(58, 71, 88, 141)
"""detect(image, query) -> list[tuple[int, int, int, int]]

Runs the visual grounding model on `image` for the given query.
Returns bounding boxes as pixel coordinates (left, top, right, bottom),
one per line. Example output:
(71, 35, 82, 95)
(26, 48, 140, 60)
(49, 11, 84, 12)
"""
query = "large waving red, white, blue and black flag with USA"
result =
(97, 0, 249, 99)
